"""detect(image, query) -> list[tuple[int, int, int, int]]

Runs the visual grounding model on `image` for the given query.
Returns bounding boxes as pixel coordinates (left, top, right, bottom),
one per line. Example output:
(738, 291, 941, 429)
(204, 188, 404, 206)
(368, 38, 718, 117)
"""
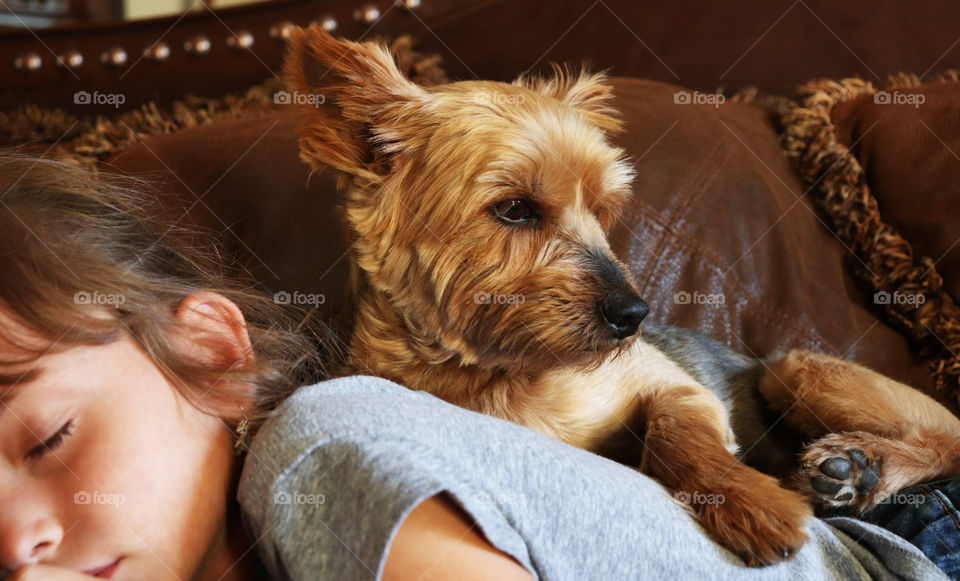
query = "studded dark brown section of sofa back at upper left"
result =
(0, 0, 485, 114)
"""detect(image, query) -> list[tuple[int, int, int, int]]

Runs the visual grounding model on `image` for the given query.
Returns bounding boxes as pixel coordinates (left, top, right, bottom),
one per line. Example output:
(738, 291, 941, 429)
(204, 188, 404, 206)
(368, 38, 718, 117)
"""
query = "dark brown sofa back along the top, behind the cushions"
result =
(7, 0, 960, 115)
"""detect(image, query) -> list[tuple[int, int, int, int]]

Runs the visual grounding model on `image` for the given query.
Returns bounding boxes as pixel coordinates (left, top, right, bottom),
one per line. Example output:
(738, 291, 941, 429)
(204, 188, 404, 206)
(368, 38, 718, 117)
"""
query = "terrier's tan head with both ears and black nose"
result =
(285, 28, 647, 370)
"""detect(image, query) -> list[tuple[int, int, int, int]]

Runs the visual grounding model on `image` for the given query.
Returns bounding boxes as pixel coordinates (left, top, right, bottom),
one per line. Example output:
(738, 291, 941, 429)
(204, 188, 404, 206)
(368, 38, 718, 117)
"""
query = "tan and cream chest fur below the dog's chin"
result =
(351, 309, 737, 464)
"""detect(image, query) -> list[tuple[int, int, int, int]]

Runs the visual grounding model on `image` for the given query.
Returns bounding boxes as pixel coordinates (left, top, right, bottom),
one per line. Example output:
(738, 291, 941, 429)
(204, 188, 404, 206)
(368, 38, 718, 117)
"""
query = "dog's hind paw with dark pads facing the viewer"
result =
(798, 432, 882, 512)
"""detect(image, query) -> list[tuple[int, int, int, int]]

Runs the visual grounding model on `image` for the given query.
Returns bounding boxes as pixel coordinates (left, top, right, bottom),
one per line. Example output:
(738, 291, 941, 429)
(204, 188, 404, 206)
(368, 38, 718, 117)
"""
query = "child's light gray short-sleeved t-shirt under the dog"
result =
(238, 376, 946, 581)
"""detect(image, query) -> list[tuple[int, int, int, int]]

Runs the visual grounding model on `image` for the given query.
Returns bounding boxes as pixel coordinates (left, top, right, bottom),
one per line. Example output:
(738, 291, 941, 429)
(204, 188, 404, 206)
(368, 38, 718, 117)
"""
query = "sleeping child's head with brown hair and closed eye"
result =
(0, 155, 327, 579)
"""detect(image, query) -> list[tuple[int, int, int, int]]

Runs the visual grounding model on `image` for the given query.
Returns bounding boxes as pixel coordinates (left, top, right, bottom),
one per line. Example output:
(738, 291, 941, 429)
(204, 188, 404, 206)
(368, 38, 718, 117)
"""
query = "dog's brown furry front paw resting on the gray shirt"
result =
(694, 467, 812, 567)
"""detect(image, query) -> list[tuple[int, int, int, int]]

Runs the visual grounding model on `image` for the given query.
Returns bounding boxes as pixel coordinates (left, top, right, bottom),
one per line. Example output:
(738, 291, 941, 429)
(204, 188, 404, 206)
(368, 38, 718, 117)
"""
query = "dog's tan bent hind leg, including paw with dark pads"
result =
(760, 351, 960, 511)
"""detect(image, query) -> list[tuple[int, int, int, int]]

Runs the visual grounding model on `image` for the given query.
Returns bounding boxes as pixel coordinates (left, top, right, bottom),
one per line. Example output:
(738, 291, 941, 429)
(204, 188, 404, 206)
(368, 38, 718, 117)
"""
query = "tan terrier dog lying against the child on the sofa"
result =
(285, 26, 960, 565)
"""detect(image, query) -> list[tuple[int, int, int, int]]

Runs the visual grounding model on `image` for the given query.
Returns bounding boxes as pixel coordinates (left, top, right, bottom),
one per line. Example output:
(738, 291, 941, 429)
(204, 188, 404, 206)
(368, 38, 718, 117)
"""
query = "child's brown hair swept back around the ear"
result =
(0, 153, 339, 440)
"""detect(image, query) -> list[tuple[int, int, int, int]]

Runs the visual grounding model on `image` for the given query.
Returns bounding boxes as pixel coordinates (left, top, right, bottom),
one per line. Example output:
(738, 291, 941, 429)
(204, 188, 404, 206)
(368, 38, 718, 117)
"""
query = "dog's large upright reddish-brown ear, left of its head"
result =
(283, 25, 424, 180)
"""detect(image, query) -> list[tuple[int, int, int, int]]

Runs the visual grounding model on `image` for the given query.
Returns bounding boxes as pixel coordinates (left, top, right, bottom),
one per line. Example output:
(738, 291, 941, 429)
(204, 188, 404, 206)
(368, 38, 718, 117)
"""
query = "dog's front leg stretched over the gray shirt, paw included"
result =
(638, 385, 811, 566)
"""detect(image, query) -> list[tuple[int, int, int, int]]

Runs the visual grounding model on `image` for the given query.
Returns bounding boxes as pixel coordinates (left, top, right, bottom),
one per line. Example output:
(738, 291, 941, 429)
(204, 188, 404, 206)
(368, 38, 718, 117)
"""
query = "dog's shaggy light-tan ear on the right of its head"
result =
(513, 63, 623, 133)
